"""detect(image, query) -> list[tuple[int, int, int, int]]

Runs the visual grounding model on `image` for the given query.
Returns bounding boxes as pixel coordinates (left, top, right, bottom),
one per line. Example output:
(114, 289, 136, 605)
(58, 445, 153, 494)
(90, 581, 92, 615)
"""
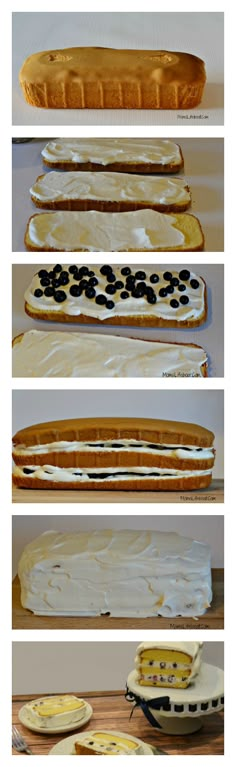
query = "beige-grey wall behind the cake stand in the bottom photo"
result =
(13, 637, 224, 695)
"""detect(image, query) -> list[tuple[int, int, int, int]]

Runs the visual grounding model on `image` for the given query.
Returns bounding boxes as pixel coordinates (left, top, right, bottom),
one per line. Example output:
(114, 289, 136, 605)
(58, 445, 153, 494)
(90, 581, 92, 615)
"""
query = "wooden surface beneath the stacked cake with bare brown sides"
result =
(12, 479, 224, 504)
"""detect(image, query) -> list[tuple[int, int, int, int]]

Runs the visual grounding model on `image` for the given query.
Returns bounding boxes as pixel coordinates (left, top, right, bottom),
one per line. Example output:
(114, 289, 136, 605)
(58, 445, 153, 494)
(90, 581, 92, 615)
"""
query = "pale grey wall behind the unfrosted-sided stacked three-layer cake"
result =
(12, 389, 224, 478)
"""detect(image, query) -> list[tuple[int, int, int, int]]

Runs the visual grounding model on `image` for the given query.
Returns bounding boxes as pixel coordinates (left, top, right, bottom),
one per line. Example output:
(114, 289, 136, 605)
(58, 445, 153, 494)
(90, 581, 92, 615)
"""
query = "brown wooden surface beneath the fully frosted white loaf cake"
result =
(12, 568, 224, 630)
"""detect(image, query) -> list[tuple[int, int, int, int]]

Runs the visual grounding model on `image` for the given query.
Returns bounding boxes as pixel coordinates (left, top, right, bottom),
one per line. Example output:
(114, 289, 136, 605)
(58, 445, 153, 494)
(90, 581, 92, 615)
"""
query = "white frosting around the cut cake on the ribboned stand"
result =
(135, 642, 203, 685)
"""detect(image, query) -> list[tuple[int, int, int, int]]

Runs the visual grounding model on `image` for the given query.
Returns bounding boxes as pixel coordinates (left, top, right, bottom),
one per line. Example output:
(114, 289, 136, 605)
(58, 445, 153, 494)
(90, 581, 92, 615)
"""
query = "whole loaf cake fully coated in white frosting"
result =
(18, 530, 212, 618)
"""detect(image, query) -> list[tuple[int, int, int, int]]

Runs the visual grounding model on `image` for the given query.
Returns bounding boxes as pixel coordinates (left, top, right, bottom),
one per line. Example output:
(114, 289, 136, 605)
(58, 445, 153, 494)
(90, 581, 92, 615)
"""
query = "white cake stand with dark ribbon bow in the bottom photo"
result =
(127, 663, 224, 735)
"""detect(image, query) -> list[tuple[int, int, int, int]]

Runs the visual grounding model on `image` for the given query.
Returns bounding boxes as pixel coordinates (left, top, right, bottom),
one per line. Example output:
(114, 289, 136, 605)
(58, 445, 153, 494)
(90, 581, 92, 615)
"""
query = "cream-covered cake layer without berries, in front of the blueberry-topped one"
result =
(12, 330, 207, 378)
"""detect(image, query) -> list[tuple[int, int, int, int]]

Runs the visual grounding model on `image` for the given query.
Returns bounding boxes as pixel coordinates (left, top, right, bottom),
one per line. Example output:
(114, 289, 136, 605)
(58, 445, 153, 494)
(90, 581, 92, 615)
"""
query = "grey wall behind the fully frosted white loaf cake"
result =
(12, 515, 224, 577)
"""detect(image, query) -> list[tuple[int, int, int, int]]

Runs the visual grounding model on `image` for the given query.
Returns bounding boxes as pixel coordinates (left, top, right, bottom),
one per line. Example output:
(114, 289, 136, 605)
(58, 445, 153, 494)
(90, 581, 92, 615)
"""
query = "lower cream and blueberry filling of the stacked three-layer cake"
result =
(13, 464, 212, 486)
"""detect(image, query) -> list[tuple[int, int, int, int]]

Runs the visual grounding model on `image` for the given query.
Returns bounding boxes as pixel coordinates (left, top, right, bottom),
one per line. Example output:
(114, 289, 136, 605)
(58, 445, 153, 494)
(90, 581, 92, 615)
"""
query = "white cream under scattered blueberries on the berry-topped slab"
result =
(24, 266, 205, 322)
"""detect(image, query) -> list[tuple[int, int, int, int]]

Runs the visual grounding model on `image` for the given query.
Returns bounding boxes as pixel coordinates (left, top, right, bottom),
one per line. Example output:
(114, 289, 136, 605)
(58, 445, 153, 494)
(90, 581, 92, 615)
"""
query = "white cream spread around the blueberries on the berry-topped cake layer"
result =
(25, 268, 205, 323)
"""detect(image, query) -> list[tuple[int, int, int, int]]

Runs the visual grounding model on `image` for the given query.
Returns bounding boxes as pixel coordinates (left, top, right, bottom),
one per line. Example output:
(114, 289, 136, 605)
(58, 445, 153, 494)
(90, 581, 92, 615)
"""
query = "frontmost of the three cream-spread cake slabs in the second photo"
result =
(25, 208, 204, 252)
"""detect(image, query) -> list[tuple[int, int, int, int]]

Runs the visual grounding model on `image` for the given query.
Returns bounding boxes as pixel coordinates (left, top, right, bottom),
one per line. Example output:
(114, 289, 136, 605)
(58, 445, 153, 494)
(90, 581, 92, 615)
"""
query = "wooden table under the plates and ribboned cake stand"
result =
(12, 690, 224, 756)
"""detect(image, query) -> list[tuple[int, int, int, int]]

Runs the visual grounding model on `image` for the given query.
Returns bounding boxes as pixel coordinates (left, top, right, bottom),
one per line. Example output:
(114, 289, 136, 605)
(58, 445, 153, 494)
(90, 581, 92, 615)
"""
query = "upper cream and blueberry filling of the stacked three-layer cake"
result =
(14, 439, 214, 461)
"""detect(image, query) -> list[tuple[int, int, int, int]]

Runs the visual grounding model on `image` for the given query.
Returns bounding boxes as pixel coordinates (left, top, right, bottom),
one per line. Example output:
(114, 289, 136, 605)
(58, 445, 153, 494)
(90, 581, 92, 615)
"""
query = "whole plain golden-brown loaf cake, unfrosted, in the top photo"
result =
(19, 47, 206, 109)
